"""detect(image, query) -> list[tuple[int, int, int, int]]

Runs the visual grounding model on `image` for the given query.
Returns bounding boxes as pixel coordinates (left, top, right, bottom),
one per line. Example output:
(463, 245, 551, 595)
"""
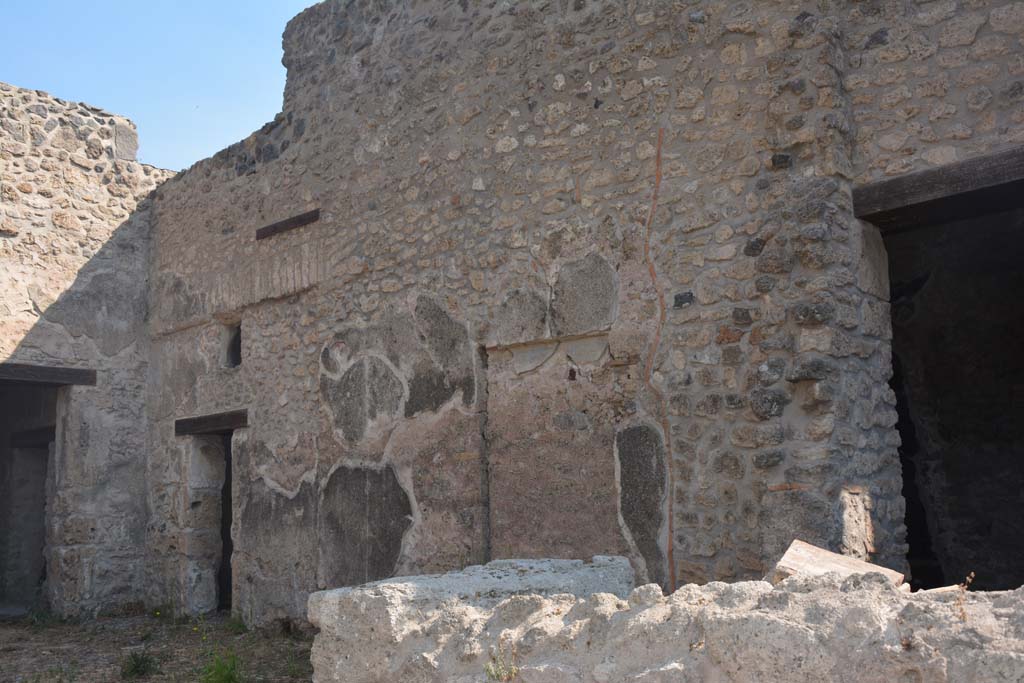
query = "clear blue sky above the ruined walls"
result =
(0, 0, 315, 170)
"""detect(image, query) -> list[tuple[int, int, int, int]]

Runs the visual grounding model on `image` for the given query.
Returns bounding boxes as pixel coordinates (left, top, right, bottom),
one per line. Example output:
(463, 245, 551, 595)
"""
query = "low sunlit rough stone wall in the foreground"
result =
(309, 563, 1024, 683)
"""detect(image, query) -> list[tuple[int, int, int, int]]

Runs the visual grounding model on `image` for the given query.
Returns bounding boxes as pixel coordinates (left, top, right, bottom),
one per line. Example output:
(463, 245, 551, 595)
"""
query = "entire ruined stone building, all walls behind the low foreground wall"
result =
(0, 0, 1024, 624)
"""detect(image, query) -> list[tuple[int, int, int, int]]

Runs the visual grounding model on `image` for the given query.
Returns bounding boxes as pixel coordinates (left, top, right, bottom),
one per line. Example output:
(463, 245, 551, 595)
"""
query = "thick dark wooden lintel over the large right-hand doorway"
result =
(853, 147, 1024, 231)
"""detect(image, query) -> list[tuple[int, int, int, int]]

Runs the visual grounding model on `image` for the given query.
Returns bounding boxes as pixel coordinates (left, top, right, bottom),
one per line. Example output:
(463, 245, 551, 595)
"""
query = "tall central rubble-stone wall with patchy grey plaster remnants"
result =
(148, 0, 905, 622)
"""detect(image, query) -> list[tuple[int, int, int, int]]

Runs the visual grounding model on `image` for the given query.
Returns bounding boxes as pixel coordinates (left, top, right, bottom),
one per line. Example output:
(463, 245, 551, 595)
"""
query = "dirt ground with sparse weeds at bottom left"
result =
(0, 612, 312, 683)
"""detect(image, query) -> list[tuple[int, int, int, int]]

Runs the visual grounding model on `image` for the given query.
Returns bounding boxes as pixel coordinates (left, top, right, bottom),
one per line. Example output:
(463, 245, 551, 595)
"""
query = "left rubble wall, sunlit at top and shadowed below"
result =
(0, 84, 167, 613)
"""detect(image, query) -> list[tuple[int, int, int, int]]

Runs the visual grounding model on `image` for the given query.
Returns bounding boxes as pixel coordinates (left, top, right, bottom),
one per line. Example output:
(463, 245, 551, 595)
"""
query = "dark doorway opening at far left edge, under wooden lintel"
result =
(0, 381, 58, 613)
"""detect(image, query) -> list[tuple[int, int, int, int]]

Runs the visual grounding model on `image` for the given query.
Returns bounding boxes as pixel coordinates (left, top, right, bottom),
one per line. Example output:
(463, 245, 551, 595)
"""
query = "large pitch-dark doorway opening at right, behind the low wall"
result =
(885, 204, 1024, 590)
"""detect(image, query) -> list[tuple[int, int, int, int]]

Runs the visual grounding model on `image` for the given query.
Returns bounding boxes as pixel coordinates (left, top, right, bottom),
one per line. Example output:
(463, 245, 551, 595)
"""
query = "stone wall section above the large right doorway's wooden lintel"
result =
(844, 0, 1024, 180)
